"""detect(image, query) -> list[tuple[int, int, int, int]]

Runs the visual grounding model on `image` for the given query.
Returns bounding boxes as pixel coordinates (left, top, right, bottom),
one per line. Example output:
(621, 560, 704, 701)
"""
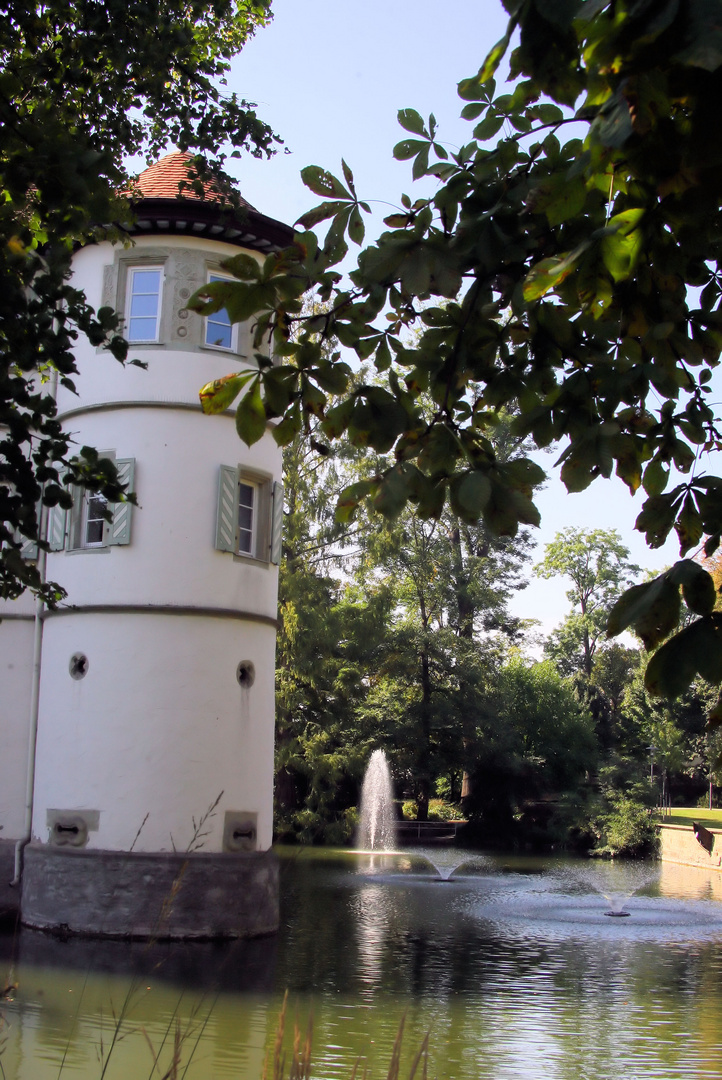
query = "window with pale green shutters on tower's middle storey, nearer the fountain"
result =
(216, 465, 283, 564)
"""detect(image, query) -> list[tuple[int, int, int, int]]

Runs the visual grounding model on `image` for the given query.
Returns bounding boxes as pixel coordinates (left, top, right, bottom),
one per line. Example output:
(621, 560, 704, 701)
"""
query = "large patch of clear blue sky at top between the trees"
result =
(229, 0, 506, 222)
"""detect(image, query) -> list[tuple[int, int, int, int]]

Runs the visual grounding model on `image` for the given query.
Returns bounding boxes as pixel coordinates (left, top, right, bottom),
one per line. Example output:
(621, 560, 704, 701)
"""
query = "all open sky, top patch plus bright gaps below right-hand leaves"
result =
(213, 0, 707, 633)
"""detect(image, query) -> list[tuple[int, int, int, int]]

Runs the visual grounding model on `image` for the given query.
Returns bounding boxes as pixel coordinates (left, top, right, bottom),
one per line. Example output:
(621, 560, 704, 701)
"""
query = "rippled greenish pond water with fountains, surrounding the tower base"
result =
(0, 850, 722, 1080)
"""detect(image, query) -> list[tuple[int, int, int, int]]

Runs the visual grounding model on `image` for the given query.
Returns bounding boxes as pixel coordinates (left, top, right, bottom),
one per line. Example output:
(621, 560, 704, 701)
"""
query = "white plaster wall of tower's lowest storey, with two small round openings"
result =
(32, 615, 275, 851)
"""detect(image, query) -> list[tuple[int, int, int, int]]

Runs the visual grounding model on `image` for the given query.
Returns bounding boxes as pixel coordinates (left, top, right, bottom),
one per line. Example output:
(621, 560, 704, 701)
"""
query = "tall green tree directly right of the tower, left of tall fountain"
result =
(274, 401, 393, 843)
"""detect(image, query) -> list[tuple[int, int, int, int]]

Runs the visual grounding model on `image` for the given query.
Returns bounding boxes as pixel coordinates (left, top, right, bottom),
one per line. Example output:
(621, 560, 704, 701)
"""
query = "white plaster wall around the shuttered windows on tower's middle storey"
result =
(47, 408, 282, 619)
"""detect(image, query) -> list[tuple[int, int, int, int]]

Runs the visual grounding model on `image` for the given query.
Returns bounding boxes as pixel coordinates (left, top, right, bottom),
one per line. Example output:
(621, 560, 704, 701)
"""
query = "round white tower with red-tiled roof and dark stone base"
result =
(16, 153, 291, 936)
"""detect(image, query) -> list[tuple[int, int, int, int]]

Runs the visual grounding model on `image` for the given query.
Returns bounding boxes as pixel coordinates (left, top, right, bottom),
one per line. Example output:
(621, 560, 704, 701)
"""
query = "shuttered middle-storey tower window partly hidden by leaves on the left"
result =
(47, 450, 135, 551)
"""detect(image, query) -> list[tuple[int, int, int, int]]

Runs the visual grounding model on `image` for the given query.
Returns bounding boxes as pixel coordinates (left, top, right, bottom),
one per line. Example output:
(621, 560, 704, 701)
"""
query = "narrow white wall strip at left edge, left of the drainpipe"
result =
(0, 596, 33, 840)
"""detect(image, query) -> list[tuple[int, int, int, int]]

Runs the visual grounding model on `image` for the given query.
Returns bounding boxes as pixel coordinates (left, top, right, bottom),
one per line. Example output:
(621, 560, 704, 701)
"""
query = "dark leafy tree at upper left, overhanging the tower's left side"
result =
(0, 0, 275, 603)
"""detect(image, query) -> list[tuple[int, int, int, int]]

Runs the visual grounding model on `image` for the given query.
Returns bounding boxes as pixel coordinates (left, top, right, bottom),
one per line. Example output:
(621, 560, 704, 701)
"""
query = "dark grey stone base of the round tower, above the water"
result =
(21, 843, 278, 941)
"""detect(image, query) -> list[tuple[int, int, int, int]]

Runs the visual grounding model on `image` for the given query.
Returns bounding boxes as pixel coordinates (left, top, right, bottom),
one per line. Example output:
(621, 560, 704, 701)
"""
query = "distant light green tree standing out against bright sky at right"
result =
(534, 528, 641, 679)
